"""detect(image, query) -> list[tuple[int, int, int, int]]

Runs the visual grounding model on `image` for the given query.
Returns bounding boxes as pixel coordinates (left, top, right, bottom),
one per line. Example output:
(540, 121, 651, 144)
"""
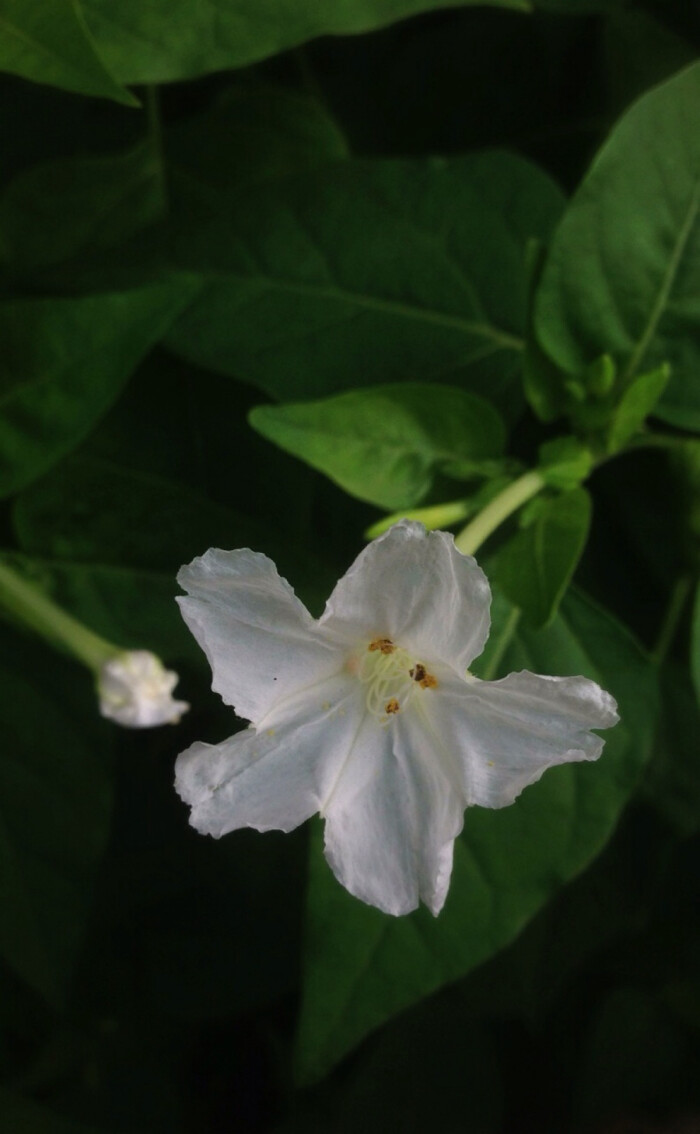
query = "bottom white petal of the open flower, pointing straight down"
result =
(323, 716, 464, 915)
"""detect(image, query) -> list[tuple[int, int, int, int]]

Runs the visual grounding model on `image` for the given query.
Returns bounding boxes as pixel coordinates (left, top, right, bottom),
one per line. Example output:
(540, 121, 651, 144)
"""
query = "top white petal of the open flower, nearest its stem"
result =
(320, 521, 491, 675)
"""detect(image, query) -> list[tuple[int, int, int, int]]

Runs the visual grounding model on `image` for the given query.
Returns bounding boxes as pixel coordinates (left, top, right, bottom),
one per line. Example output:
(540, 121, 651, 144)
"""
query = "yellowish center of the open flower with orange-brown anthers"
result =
(357, 638, 438, 725)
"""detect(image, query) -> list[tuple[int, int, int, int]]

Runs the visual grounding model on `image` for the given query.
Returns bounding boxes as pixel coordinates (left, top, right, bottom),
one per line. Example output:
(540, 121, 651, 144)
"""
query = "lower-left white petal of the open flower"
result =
(175, 675, 364, 838)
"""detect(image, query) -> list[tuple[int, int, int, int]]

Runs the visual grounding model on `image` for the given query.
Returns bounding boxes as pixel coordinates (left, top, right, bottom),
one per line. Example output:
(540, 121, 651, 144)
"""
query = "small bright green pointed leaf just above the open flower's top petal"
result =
(250, 382, 505, 508)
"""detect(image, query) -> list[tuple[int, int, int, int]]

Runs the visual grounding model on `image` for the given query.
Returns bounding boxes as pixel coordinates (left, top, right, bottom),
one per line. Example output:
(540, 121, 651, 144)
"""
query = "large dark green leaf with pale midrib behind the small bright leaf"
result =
(168, 153, 560, 416)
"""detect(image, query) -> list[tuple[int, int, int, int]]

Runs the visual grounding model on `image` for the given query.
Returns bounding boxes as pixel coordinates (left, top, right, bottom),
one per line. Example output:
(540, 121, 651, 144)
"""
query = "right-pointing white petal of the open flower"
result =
(423, 671, 618, 807)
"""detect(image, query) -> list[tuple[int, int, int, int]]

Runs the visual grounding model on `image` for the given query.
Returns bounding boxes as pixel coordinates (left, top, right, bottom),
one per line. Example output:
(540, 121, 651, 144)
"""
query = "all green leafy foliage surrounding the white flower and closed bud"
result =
(0, 0, 700, 1134)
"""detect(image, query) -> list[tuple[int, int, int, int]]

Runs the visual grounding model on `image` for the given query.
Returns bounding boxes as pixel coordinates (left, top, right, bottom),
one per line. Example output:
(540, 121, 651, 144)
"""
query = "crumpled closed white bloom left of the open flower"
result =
(98, 650, 189, 728)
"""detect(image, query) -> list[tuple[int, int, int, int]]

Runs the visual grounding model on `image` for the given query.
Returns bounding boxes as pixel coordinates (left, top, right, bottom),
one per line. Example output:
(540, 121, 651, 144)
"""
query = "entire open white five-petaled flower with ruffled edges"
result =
(176, 521, 618, 914)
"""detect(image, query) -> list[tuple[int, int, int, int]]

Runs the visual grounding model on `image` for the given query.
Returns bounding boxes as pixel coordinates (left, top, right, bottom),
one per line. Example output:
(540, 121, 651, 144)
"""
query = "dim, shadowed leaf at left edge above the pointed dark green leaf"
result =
(0, 143, 163, 271)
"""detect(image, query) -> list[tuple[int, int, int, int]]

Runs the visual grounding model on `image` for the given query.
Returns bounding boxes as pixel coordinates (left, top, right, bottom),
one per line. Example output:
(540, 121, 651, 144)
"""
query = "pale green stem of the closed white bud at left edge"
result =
(0, 562, 114, 672)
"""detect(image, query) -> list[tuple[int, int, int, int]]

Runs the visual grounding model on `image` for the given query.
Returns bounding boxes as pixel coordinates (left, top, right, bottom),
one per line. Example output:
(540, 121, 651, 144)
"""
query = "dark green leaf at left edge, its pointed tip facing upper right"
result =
(0, 276, 197, 496)
